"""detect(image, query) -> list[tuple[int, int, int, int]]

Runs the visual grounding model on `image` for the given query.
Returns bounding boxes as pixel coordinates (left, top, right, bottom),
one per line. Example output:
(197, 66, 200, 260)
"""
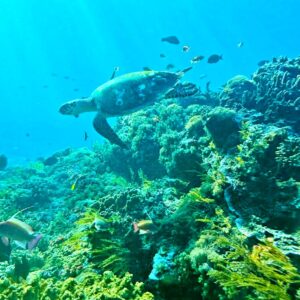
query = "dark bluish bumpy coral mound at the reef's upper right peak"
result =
(220, 57, 300, 133)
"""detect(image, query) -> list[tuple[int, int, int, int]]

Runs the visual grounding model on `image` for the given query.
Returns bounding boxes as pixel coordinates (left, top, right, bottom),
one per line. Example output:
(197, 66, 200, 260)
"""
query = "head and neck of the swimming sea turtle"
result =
(59, 98, 96, 118)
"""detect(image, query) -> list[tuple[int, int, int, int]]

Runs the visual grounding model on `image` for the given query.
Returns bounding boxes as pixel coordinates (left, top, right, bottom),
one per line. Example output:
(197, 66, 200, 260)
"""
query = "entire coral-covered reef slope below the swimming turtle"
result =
(0, 57, 300, 300)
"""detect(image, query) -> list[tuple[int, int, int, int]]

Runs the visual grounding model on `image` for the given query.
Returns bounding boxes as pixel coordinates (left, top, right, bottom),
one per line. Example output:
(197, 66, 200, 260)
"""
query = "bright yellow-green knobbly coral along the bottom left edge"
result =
(0, 271, 154, 300)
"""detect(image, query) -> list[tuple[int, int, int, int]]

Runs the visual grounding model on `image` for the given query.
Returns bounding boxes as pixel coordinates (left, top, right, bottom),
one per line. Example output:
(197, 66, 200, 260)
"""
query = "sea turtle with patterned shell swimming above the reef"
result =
(59, 68, 196, 148)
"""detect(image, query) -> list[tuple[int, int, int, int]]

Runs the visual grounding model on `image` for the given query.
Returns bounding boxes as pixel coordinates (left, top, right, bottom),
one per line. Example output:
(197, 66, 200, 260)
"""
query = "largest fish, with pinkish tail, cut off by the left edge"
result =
(0, 207, 42, 250)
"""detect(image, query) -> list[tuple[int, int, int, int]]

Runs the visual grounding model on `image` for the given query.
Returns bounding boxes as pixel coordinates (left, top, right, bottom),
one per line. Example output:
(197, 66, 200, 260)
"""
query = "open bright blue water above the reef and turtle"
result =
(0, 0, 300, 164)
